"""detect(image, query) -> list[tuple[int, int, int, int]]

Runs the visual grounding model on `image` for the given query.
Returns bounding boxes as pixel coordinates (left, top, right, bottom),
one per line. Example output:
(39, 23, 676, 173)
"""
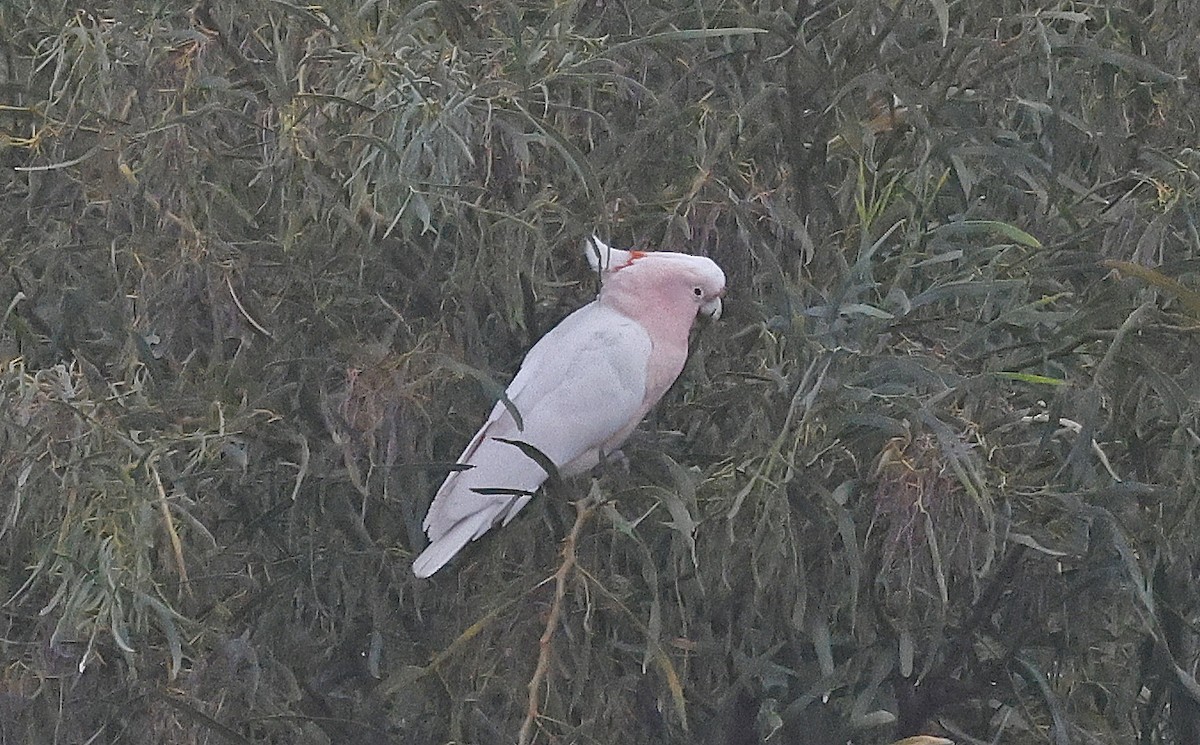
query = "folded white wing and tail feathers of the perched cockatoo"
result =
(413, 302, 652, 577)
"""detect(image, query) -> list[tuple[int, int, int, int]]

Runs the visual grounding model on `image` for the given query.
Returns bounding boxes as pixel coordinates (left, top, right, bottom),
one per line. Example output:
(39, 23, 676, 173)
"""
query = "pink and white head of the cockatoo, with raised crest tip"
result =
(586, 236, 725, 325)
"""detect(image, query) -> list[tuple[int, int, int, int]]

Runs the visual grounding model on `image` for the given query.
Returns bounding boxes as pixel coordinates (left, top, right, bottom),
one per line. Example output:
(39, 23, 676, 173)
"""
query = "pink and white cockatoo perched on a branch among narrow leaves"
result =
(413, 238, 725, 577)
